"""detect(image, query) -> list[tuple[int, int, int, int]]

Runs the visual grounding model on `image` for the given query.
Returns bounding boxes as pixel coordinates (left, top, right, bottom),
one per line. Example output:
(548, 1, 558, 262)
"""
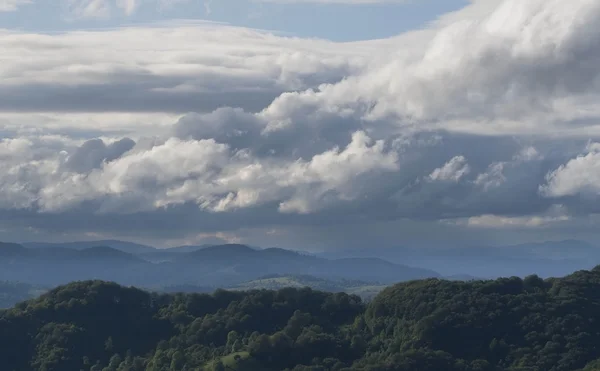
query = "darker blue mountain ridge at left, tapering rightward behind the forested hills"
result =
(0, 241, 440, 289)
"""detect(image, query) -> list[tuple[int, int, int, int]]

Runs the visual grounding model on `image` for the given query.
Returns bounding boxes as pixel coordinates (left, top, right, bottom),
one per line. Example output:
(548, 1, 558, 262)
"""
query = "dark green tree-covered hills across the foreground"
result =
(5, 268, 600, 371)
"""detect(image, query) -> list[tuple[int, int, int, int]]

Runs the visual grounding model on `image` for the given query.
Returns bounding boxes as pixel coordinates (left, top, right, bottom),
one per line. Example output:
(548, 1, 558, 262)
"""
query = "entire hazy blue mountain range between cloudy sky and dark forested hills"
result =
(5, 240, 600, 288)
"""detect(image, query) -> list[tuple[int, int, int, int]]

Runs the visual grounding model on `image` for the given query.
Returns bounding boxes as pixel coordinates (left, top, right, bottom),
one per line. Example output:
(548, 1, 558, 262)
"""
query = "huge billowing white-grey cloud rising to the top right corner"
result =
(260, 0, 600, 135)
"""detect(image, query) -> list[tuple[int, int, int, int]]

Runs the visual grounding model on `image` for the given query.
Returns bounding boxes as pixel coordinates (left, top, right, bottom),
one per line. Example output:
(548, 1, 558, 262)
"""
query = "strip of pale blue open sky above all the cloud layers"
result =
(0, 0, 468, 41)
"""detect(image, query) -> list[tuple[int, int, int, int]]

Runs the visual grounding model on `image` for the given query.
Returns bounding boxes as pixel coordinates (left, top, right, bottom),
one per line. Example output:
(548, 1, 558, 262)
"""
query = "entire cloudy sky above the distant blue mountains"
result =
(0, 0, 600, 251)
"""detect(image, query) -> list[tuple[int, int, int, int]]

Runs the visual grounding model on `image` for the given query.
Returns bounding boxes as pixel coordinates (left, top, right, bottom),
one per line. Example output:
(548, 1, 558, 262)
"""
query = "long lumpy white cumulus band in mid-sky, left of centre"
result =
(31, 132, 397, 213)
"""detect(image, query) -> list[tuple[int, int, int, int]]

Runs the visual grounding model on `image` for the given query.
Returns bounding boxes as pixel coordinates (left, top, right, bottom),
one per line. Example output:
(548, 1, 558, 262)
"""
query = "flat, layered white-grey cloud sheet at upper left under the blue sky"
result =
(0, 23, 375, 113)
